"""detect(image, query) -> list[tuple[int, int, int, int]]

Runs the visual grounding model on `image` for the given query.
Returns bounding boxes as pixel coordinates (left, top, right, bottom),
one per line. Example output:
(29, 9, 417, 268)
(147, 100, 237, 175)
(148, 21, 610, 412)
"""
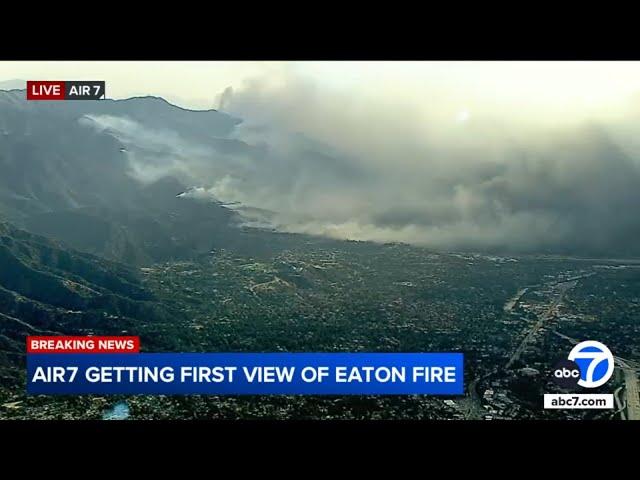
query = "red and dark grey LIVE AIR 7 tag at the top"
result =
(27, 80, 106, 100)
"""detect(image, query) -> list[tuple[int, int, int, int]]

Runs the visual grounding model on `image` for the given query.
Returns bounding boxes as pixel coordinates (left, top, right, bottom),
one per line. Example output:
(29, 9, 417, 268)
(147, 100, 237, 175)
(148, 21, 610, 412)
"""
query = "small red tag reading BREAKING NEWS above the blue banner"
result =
(27, 336, 140, 353)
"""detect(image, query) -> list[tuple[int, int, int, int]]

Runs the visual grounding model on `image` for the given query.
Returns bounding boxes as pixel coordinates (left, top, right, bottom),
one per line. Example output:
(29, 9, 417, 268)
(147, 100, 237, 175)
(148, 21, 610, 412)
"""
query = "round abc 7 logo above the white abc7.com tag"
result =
(551, 340, 614, 388)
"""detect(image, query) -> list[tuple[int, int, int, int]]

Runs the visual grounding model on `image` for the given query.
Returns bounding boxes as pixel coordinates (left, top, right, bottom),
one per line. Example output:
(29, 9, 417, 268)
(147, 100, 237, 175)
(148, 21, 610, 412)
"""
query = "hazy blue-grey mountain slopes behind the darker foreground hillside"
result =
(0, 90, 262, 265)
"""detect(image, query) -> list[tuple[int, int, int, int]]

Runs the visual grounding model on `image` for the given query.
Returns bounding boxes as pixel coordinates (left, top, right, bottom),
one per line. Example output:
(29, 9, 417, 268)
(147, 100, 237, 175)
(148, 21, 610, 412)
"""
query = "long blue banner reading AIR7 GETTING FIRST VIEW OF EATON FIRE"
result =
(27, 353, 464, 395)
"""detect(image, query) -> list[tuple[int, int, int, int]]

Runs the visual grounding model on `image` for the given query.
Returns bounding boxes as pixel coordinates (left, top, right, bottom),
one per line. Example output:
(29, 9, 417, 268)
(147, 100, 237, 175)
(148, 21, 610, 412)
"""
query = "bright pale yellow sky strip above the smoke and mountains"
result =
(0, 61, 640, 122)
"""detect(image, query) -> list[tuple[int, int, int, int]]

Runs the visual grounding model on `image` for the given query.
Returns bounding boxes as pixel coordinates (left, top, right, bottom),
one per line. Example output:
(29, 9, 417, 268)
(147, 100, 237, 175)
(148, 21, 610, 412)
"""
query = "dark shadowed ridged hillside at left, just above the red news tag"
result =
(0, 223, 181, 386)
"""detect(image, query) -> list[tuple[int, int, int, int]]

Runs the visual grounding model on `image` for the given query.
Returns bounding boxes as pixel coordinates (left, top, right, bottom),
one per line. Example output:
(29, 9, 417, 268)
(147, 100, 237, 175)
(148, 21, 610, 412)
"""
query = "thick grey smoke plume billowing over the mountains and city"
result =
(84, 71, 640, 255)
